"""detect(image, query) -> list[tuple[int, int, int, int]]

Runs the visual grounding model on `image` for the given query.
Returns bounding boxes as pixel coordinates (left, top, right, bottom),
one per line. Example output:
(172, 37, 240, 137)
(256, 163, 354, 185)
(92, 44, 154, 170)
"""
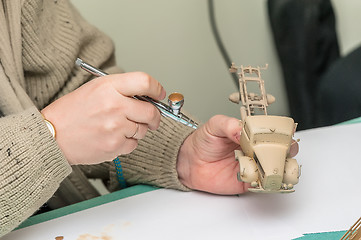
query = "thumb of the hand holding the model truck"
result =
(207, 115, 242, 144)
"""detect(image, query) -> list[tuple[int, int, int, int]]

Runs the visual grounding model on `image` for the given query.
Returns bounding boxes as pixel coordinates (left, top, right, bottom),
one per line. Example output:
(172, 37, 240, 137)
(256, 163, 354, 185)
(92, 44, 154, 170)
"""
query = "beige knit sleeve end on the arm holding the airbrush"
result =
(0, 107, 71, 232)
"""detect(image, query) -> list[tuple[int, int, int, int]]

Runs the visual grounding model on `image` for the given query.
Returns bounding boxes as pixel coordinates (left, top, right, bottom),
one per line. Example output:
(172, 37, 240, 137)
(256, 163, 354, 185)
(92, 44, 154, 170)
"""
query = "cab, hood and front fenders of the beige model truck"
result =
(236, 115, 299, 192)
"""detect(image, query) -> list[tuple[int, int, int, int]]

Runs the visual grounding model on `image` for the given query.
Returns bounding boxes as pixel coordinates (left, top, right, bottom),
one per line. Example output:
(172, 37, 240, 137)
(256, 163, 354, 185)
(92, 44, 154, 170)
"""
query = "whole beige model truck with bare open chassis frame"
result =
(229, 64, 300, 193)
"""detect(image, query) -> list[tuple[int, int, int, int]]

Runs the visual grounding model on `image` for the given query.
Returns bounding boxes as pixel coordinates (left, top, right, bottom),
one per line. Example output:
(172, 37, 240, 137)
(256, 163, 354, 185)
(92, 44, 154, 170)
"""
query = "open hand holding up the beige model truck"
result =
(177, 115, 298, 195)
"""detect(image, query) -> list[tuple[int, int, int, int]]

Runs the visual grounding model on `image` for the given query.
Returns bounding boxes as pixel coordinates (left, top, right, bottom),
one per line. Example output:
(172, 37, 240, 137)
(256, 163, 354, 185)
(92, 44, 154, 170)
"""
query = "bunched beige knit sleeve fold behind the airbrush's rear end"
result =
(21, 0, 114, 108)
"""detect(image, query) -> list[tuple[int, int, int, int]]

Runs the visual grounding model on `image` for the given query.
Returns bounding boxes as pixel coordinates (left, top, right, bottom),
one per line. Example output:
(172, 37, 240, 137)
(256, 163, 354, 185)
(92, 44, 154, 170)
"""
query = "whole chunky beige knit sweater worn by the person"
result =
(0, 0, 192, 237)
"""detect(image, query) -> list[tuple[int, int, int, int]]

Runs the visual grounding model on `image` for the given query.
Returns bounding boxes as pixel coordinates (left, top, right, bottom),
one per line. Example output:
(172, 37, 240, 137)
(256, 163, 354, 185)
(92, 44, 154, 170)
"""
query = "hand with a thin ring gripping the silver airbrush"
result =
(41, 72, 166, 164)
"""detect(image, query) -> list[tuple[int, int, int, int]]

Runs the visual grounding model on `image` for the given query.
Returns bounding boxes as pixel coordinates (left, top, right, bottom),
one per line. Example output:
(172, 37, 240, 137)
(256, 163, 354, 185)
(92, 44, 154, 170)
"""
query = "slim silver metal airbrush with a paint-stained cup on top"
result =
(75, 58, 198, 129)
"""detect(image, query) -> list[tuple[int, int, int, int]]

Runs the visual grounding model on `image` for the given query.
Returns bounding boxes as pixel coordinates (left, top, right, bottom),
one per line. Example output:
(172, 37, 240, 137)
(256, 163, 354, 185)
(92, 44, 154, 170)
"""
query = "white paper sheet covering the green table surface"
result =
(2, 124, 361, 240)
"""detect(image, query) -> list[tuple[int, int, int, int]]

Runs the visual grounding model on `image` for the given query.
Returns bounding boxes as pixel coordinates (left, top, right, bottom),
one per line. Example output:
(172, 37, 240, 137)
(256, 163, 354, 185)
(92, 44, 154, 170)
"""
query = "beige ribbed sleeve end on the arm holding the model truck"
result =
(120, 118, 194, 191)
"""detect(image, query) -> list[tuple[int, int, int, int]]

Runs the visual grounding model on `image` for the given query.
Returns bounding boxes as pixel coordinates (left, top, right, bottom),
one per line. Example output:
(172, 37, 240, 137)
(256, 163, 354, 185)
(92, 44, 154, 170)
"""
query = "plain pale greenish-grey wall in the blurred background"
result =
(72, 0, 361, 121)
